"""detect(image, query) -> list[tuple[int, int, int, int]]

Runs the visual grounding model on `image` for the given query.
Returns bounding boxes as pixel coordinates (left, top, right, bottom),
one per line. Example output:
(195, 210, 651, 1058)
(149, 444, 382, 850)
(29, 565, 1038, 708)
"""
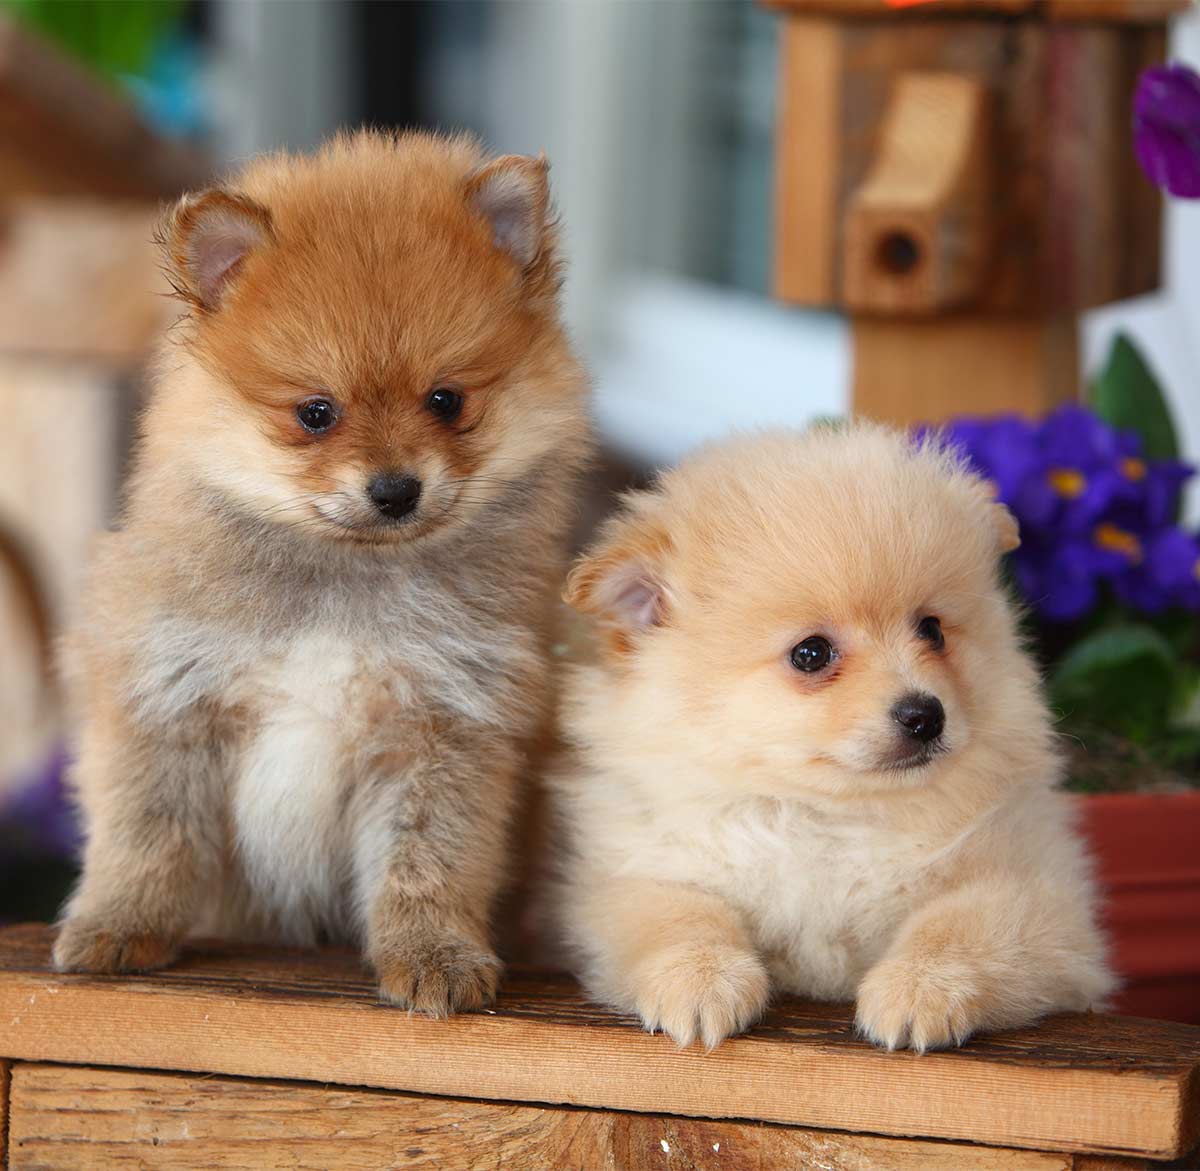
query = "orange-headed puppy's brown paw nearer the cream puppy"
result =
(376, 933, 502, 1016)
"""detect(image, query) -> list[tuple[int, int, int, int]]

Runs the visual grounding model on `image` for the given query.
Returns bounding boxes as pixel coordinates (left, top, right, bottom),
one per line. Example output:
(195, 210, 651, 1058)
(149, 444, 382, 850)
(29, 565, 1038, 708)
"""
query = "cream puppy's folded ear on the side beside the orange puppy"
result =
(563, 512, 671, 645)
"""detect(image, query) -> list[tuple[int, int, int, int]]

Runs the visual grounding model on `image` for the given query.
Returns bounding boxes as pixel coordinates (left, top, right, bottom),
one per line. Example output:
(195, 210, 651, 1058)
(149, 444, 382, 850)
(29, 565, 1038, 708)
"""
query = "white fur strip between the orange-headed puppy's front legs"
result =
(233, 636, 362, 943)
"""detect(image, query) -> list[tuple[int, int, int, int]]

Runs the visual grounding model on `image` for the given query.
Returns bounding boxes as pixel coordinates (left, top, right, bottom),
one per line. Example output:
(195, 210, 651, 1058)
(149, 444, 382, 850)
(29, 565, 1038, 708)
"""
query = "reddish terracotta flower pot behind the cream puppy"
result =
(1080, 792, 1200, 1023)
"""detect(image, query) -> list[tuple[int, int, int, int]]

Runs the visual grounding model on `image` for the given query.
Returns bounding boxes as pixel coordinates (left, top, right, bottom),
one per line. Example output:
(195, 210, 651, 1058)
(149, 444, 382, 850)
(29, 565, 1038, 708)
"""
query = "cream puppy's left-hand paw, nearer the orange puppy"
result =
(635, 943, 770, 1049)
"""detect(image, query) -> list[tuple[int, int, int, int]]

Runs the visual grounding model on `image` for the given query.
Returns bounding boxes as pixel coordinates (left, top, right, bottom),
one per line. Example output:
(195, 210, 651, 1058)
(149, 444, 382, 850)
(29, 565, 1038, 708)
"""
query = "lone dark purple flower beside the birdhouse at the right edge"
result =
(1133, 65, 1200, 199)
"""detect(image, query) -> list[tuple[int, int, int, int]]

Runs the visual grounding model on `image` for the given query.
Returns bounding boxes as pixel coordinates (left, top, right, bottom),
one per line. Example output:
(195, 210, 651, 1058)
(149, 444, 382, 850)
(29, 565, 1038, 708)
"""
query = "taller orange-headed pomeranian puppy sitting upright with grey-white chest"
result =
(54, 133, 589, 1014)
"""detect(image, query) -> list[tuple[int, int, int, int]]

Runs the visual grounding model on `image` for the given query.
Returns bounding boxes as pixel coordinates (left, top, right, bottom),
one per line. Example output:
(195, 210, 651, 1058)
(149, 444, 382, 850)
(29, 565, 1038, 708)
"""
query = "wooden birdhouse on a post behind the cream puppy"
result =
(772, 0, 1188, 422)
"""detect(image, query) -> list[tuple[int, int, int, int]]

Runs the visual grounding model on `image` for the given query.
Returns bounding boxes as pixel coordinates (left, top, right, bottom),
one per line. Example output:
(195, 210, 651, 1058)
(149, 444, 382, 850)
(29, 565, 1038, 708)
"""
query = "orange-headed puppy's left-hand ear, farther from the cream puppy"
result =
(155, 190, 272, 310)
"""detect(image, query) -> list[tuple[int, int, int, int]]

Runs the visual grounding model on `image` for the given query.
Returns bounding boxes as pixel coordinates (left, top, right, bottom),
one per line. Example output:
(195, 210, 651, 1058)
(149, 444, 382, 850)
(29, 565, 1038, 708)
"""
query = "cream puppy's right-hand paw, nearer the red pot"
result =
(857, 959, 986, 1053)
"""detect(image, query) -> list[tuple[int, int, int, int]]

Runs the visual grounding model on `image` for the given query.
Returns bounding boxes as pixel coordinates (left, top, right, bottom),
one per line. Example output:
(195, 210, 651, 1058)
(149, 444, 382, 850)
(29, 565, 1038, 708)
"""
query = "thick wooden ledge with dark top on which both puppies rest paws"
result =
(0, 925, 1200, 1159)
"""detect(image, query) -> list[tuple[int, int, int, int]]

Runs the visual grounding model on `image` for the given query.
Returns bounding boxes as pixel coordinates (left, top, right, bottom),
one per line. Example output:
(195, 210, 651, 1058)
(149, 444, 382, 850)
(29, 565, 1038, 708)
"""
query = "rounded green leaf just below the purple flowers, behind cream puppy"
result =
(1050, 623, 1180, 744)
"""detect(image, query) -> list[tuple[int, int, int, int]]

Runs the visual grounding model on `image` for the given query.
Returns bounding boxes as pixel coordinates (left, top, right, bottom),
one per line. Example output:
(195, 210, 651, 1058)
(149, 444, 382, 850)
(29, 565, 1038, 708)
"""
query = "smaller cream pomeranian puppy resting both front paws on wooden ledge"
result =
(553, 425, 1112, 1051)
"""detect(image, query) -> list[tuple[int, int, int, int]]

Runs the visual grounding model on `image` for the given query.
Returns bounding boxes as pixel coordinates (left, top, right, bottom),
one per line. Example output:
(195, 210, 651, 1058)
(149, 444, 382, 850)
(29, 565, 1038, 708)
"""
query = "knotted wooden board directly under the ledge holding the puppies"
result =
(10, 1064, 1145, 1171)
